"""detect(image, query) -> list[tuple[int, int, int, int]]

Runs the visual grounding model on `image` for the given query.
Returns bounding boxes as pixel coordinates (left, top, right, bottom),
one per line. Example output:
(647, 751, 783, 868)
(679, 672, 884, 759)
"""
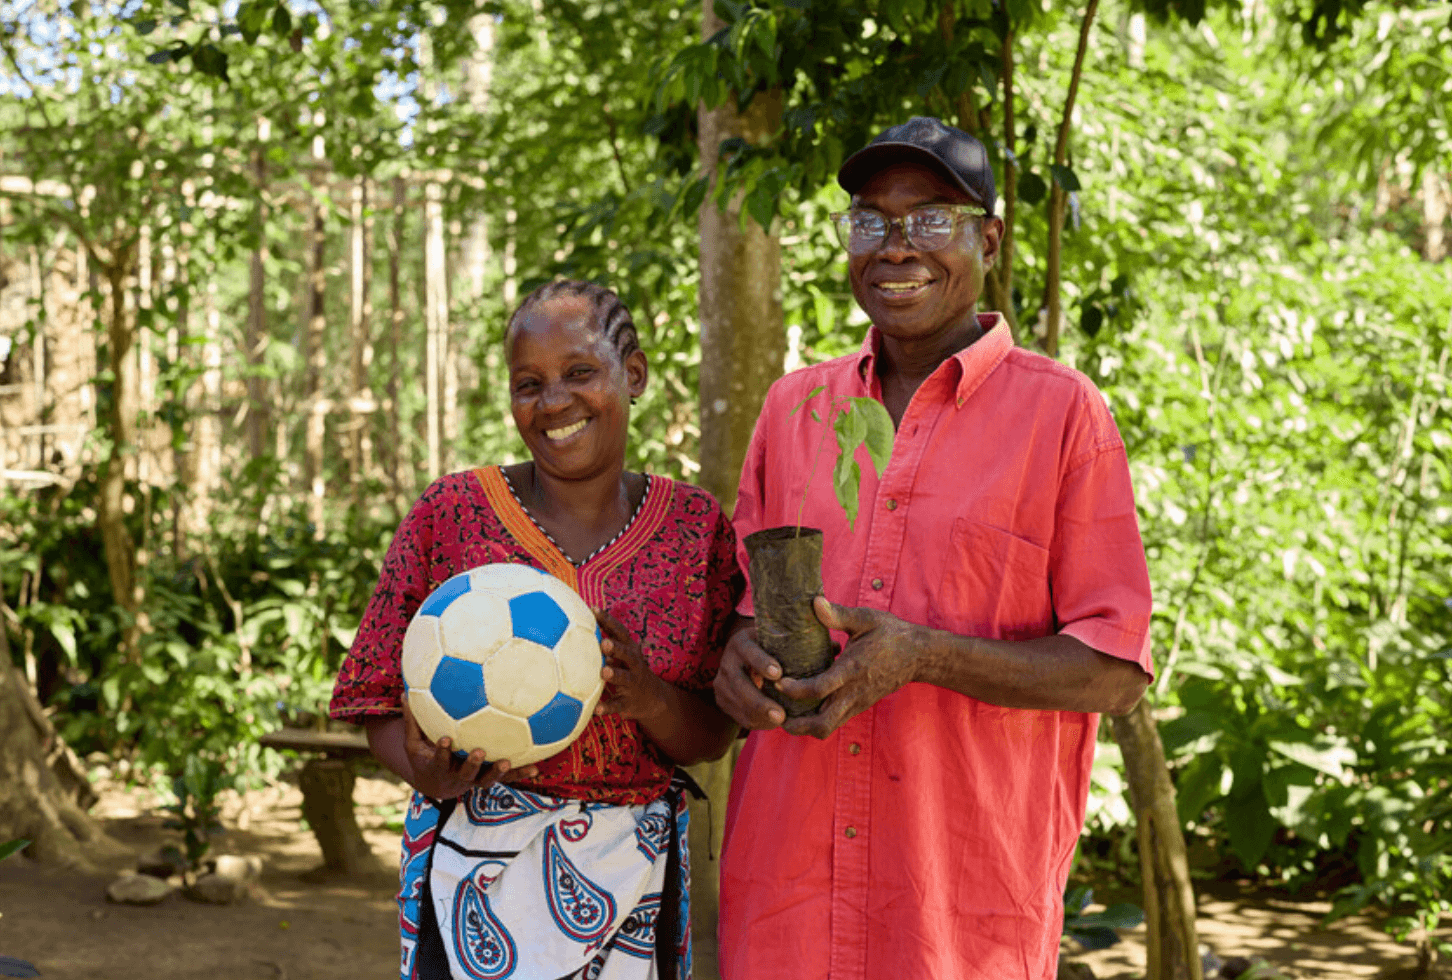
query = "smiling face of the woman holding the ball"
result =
(505, 296, 646, 479)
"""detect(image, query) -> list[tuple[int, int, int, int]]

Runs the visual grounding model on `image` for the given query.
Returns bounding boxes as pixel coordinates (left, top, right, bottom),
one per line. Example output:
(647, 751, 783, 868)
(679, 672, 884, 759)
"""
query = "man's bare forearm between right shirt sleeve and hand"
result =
(915, 630, 1150, 714)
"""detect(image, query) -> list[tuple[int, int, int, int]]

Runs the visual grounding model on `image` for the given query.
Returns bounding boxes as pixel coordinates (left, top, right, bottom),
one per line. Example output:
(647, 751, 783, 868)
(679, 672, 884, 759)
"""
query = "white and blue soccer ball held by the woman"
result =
(404, 565, 604, 767)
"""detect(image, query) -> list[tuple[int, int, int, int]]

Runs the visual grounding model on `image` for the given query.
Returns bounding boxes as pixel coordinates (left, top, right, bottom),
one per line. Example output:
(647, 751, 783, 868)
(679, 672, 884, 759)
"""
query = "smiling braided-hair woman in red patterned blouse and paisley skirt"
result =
(331, 280, 741, 980)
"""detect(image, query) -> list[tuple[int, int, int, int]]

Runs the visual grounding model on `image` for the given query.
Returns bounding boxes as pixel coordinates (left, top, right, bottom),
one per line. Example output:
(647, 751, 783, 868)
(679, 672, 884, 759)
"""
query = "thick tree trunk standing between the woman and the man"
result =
(690, 0, 787, 977)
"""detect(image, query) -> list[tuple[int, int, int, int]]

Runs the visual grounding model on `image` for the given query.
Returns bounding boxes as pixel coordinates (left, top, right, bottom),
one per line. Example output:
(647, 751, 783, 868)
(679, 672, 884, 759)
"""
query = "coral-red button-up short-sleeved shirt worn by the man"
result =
(720, 314, 1150, 980)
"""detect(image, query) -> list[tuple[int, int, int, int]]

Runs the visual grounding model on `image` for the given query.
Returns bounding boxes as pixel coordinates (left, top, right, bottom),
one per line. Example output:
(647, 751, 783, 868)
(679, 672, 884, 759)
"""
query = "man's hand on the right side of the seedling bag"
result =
(777, 595, 929, 739)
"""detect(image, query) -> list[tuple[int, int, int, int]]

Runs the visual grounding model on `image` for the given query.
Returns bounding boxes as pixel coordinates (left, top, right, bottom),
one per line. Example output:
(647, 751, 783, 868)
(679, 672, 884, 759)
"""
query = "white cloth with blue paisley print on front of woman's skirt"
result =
(428, 785, 690, 980)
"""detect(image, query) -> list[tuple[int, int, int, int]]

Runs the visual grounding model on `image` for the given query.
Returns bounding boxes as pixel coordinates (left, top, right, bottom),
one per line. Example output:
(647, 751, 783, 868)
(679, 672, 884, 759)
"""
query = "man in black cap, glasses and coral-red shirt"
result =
(716, 118, 1150, 980)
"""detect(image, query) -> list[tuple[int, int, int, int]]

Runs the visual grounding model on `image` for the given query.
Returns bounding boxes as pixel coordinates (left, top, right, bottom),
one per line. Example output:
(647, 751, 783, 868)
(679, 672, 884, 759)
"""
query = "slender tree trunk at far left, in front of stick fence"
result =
(96, 255, 141, 663)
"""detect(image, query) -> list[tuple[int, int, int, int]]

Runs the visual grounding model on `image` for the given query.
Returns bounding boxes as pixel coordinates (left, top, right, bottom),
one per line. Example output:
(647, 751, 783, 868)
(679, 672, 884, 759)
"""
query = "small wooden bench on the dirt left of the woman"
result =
(258, 729, 388, 877)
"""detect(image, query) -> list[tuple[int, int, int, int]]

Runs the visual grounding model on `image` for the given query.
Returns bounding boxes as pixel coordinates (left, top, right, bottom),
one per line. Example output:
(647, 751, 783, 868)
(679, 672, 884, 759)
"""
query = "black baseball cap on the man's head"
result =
(836, 116, 998, 213)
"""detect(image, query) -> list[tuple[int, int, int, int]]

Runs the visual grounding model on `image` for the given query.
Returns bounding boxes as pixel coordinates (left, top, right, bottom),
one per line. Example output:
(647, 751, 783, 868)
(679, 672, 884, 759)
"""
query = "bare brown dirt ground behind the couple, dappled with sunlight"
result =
(0, 778, 1452, 980)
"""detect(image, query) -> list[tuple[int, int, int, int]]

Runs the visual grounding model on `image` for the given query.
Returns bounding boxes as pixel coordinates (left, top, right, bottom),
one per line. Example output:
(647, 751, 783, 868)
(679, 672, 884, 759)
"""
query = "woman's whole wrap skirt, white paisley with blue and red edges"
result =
(398, 777, 694, 980)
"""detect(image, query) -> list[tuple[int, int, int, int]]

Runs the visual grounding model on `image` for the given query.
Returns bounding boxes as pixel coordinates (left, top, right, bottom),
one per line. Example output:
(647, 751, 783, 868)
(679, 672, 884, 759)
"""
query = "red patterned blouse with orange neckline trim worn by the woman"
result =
(330, 466, 742, 804)
